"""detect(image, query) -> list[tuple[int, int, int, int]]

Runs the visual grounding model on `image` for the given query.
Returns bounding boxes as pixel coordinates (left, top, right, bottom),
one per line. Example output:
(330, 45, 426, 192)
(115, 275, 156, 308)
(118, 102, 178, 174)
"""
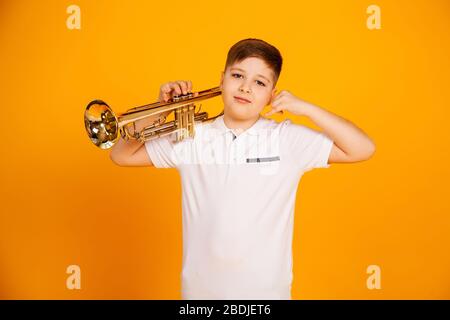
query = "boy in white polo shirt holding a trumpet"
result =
(111, 39, 375, 299)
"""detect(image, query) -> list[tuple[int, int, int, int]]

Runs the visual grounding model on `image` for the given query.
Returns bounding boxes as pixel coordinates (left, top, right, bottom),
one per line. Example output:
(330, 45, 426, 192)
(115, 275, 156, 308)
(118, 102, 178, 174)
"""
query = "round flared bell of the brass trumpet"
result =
(84, 100, 119, 149)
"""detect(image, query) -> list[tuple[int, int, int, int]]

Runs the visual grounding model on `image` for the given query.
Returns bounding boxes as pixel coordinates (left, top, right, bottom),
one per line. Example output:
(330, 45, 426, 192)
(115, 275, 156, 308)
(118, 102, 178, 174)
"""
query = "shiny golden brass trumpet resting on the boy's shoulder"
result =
(84, 87, 223, 149)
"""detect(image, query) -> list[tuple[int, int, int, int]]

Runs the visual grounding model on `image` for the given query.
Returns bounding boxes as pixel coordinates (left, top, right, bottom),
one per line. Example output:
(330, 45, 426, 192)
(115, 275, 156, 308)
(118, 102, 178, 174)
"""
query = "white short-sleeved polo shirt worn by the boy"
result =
(145, 116, 333, 299)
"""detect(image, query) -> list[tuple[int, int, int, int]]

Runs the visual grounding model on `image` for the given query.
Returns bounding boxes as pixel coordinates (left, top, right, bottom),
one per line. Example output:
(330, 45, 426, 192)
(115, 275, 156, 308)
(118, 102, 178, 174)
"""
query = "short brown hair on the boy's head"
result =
(225, 38, 283, 86)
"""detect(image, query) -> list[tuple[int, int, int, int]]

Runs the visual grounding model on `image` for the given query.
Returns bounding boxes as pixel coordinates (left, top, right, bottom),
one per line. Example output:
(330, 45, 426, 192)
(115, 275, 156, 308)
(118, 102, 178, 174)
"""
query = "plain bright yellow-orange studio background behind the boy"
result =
(0, 0, 450, 299)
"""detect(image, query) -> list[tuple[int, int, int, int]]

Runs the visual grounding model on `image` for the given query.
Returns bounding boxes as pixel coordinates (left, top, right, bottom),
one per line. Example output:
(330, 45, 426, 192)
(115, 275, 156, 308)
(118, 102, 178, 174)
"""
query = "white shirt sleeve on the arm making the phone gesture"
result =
(281, 120, 333, 171)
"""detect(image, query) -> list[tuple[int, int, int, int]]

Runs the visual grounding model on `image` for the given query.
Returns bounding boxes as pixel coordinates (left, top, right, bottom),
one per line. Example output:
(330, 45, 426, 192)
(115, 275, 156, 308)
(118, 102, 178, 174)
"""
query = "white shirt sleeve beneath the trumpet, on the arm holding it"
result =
(145, 134, 179, 168)
